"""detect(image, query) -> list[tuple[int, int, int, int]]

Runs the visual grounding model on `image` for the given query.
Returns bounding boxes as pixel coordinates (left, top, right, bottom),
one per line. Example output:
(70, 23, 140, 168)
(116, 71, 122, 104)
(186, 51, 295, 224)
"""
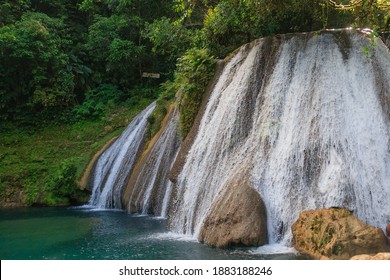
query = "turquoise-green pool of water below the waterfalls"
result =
(0, 208, 303, 260)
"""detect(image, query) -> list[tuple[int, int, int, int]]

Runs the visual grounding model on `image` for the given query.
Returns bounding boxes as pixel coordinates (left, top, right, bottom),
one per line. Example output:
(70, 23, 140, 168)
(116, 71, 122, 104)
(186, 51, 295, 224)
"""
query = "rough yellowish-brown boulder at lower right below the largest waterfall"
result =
(292, 208, 389, 259)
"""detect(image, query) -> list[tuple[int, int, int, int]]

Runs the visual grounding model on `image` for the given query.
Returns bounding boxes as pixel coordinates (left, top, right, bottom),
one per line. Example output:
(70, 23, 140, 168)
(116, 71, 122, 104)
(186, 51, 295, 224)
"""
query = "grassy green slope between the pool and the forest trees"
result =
(0, 98, 151, 205)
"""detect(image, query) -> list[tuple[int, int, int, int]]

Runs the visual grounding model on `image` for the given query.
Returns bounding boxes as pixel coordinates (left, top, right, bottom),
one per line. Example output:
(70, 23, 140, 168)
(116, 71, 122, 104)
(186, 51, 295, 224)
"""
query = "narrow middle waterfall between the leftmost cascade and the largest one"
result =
(124, 108, 180, 217)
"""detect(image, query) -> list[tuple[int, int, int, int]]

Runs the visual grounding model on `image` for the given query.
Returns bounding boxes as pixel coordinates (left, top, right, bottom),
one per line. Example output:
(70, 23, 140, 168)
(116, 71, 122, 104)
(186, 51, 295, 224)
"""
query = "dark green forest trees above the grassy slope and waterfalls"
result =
(0, 0, 390, 123)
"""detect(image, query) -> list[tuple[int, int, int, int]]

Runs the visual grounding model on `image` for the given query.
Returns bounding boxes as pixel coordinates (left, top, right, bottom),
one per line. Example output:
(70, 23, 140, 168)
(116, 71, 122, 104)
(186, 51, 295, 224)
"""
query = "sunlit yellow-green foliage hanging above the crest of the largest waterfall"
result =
(184, 0, 390, 58)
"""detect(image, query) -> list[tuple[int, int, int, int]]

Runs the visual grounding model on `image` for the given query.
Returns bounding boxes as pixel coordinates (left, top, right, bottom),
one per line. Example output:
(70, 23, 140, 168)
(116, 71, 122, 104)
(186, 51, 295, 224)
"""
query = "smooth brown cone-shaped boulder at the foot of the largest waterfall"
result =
(199, 180, 267, 248)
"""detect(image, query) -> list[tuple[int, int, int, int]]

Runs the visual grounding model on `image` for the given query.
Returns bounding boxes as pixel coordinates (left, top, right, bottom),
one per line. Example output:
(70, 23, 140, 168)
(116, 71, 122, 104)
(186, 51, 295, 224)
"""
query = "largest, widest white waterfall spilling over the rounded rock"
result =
(171, 30, 390, 245)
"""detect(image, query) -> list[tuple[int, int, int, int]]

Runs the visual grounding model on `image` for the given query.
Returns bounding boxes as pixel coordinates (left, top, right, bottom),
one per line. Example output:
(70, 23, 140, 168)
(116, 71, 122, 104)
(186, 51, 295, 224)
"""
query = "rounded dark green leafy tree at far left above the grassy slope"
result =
(0, 13, 75, 119)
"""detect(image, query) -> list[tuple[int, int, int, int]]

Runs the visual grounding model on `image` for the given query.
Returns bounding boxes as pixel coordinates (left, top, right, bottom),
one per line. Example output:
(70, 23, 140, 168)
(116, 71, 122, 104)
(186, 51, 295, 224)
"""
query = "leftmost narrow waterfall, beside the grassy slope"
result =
(89, 102, 156, 209)
